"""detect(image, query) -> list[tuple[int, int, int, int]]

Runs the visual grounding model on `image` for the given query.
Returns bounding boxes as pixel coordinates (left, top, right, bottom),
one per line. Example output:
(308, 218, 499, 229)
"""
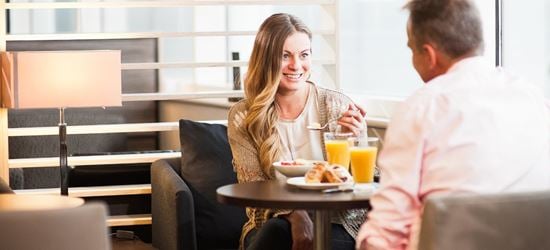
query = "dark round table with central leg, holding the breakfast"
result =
(217, 180, 371, 250)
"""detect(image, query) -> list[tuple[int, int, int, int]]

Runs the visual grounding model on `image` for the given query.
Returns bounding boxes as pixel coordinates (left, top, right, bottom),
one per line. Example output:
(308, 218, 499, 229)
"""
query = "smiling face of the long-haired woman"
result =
(279, 32, 311, 91)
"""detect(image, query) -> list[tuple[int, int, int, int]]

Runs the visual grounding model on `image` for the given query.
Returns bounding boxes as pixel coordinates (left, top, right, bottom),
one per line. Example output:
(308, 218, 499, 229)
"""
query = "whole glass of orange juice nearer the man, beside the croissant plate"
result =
(350, 136, 378, 184)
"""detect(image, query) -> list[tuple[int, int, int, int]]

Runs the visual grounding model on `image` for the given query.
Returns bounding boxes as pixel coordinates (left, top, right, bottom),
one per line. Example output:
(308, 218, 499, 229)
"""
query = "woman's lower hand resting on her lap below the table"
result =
(286, 210, 313, 250)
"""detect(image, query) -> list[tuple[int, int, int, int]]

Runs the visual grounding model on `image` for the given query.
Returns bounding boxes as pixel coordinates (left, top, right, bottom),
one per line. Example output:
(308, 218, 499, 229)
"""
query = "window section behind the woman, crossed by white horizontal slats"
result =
(9, 0, 337, 92)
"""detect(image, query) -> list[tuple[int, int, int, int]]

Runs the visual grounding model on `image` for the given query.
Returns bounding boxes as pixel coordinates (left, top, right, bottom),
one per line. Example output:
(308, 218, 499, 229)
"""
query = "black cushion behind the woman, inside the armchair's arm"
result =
(179, 119, 246, 249)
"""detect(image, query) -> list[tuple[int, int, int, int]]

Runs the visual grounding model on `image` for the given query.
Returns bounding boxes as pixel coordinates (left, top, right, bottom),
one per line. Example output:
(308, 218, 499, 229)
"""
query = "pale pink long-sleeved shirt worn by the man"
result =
(360, 57, 550, 249)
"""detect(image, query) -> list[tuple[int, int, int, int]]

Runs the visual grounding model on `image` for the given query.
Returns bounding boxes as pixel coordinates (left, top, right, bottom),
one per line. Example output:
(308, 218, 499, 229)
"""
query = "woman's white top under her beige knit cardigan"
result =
(277, 85, 323, 161)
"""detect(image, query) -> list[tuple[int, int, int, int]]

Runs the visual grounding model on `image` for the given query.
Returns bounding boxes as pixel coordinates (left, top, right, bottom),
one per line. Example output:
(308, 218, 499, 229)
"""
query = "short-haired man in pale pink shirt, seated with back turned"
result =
(356, 0, 550, 249)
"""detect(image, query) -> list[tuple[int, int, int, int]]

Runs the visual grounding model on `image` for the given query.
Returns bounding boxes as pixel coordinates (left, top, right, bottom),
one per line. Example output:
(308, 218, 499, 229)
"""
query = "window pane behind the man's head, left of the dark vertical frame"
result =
(339, 0, 495, 118)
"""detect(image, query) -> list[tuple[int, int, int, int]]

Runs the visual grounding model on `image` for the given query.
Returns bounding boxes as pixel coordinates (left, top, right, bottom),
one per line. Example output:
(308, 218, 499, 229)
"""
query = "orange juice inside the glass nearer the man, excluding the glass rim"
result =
(350, 147, 378, 183)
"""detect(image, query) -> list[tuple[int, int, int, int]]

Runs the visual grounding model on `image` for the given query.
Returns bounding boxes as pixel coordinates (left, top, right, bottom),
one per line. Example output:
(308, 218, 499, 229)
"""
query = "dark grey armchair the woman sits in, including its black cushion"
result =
(151, 120, 246, 250)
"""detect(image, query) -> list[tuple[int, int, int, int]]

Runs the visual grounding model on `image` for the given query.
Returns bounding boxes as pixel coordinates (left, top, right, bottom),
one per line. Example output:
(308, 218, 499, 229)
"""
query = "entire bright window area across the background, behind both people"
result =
(10, 0, 550, 120)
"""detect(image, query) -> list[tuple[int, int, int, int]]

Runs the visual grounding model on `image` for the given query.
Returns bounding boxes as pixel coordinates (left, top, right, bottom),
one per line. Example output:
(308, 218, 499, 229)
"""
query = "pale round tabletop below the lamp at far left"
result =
(0, 194, 84, 211)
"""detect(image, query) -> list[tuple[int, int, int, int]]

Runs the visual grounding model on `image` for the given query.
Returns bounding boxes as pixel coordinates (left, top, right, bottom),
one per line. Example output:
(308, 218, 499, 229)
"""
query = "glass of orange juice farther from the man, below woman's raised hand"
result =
(323, 132, 354, 171)
